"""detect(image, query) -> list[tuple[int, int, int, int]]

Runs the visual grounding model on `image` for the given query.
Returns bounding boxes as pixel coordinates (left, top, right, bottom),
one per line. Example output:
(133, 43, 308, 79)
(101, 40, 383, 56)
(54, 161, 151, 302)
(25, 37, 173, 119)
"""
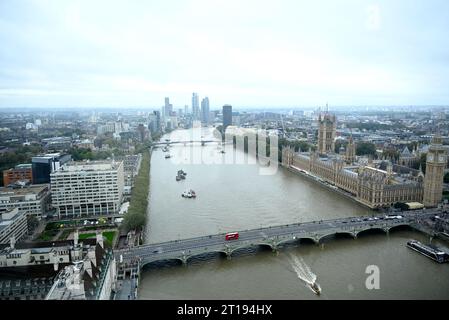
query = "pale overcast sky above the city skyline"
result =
(0, 0, 449, 109)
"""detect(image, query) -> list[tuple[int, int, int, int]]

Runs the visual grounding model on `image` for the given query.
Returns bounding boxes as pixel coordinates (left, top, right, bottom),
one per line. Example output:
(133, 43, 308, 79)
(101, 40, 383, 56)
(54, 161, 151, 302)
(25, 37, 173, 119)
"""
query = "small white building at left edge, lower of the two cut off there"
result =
(0, 208, 28, 244)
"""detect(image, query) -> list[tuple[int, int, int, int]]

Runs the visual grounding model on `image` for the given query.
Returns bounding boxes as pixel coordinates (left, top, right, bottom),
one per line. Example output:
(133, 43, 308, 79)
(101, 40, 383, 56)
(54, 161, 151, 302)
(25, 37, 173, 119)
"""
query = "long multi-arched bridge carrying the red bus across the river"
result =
(115, 209, 440, 266)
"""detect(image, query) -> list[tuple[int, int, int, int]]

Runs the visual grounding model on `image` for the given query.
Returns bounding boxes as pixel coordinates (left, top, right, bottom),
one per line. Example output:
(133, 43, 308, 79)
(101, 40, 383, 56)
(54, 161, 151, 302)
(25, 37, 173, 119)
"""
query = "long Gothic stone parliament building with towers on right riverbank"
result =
(282, 112, 447, 209)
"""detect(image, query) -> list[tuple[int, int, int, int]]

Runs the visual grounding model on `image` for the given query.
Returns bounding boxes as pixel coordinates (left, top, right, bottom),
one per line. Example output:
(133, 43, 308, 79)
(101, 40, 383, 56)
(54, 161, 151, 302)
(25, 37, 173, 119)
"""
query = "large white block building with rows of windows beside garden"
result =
(50, 161, 124, 217)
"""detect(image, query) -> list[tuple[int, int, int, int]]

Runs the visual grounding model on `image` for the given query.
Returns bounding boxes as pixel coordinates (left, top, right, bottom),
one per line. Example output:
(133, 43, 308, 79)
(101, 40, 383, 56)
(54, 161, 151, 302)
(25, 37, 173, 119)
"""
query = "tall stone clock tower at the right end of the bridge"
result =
(423, 134, 447, 207)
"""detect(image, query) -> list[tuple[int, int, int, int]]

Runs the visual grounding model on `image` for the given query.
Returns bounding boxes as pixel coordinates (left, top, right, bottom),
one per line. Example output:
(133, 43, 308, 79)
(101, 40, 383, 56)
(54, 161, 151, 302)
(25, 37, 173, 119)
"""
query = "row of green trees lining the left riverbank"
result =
(122, 150, 150, 232)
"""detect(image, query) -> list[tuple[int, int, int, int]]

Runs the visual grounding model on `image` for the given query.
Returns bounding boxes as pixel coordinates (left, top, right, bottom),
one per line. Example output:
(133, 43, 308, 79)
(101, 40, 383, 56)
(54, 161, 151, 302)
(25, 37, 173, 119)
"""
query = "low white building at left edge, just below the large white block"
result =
(0, 184, 50, 219)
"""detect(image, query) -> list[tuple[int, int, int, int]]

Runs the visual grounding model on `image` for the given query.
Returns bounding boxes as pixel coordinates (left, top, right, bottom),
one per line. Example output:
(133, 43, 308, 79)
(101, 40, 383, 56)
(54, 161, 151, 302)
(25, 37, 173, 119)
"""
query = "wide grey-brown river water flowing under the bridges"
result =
(139, 128, 449, 299)
